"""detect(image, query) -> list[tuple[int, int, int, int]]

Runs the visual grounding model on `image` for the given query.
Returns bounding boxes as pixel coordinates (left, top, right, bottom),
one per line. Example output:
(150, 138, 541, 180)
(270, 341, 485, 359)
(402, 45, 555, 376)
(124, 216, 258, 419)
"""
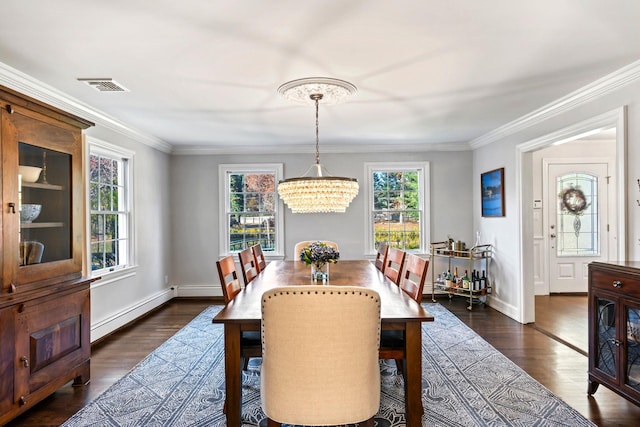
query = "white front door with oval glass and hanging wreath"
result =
(547, 162, 613, 293)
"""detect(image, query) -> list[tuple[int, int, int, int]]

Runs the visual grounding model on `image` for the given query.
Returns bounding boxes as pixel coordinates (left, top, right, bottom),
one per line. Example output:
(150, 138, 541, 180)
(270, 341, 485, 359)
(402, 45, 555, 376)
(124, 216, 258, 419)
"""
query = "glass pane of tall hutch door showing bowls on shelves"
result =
(18, 142, 72, 267)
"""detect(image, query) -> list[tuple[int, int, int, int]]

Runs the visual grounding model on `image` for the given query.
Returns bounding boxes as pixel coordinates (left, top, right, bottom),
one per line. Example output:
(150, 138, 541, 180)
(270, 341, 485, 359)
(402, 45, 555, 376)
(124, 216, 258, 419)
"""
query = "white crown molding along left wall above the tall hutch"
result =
(0, 62, 172, 153)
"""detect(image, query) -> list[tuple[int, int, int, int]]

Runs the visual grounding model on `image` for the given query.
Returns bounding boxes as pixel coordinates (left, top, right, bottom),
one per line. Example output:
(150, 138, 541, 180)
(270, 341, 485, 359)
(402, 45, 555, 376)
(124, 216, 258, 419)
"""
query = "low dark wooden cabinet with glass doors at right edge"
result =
(587, 262, 640, 405)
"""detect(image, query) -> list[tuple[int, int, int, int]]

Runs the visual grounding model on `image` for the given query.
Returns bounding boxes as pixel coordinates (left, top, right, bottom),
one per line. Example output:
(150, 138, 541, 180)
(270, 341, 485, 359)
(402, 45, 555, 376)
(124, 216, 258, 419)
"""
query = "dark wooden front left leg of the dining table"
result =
(224, 323, 242, 427)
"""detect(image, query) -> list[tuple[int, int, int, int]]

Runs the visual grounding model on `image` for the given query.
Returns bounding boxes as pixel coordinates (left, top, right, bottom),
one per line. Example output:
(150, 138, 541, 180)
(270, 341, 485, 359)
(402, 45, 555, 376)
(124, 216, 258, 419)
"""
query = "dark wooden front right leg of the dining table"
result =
(404, 322, 424, 427)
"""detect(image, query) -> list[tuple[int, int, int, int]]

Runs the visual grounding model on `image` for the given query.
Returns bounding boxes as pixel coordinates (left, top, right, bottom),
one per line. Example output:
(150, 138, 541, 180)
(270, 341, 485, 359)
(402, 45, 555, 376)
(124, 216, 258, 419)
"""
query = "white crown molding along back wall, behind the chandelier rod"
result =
(171, 142, 471, 156)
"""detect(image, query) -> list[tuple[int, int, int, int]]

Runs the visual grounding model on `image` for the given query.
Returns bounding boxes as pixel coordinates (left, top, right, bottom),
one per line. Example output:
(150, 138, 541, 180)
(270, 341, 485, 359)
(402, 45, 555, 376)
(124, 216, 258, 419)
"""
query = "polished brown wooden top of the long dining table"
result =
(213, 260, 433, 324)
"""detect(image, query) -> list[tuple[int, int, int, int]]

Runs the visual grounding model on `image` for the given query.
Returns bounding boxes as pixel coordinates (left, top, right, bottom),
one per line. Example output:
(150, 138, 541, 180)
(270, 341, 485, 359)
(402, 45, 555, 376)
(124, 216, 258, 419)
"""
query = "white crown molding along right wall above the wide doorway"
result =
(469, 61, 640, 150)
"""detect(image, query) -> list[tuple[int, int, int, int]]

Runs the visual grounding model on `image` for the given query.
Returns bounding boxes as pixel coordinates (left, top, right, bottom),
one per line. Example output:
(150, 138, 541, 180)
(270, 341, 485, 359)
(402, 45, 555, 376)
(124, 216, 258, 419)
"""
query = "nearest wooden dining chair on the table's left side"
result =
(216, 255, 262, 371)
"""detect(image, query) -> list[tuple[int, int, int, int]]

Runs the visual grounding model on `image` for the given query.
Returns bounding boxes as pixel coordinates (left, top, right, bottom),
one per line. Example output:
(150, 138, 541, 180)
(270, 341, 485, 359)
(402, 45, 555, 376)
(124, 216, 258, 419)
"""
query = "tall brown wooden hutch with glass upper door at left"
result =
(0, 87, 92, 425)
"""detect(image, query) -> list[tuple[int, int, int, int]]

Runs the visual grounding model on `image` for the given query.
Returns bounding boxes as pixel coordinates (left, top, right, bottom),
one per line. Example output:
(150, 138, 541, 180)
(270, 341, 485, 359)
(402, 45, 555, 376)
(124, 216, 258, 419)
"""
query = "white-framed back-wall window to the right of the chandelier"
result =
(365, 162, 430, 255)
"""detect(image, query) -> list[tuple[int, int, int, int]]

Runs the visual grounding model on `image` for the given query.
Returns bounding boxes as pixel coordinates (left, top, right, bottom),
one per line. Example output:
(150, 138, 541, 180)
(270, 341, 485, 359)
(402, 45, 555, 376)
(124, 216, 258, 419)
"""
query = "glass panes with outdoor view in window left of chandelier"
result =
(227, 172, 276, 252)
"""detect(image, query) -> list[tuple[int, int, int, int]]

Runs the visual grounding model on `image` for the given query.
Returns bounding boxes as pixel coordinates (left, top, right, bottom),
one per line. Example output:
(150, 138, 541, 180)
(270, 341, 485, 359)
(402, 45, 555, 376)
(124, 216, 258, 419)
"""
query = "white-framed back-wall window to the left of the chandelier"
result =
(218, 163, 284, 256)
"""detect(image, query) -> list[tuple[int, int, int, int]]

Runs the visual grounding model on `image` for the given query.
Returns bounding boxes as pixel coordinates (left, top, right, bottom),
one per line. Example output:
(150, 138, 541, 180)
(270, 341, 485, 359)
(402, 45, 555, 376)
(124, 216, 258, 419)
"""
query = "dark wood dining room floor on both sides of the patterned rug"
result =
(7, 296, 640, 427)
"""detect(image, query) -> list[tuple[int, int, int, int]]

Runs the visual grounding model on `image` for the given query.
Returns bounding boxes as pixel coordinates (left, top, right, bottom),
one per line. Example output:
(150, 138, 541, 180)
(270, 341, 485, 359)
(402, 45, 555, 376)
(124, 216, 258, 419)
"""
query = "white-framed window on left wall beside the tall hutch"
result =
(87, 138, 134, 276)
